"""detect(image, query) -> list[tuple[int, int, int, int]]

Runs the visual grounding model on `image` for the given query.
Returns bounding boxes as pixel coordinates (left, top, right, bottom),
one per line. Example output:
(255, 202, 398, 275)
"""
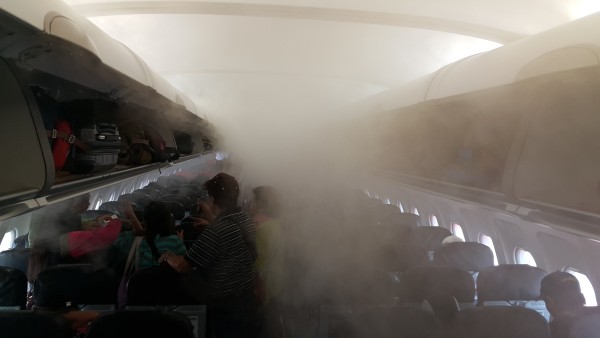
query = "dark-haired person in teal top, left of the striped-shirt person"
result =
(115, 201, 185, 268)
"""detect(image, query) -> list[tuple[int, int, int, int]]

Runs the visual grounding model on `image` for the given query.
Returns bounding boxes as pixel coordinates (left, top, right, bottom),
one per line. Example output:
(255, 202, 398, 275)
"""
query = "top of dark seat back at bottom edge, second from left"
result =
(85, 310, 194, 338)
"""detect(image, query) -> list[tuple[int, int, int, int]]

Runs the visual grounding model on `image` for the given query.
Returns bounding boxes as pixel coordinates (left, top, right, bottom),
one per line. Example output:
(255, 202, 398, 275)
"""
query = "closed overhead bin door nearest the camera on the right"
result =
(514, 67, 600, 213)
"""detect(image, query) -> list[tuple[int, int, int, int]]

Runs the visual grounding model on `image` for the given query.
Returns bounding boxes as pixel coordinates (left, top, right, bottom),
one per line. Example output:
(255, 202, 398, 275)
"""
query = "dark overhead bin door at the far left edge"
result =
(0, 59, 53, 206)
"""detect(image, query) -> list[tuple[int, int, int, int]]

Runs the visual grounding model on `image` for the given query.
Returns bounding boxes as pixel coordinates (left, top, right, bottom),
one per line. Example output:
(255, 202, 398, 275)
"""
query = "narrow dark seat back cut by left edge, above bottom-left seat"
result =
(0, 266, 27, 310)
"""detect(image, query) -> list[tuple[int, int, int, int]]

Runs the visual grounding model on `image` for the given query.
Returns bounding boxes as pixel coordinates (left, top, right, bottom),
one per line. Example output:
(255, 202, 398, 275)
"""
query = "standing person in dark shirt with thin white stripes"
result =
(160, 173, 256, 338)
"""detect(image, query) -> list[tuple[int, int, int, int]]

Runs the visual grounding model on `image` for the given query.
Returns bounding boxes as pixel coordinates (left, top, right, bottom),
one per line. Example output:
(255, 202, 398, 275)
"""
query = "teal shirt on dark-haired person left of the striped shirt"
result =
(115, 231, 186, 268)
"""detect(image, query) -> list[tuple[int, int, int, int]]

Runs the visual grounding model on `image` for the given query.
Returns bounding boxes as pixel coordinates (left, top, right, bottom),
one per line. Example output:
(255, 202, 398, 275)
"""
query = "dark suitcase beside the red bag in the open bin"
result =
(65, 116, 121, 174)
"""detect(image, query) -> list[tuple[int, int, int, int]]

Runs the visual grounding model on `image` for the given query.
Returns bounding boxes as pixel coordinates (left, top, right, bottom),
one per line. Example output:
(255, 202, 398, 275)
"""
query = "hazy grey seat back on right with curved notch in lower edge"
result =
(400, 266, 475, 305)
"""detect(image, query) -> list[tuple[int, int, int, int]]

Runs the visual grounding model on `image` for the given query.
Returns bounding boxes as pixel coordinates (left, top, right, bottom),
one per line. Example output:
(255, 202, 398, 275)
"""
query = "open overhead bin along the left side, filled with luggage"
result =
(0, 10, 217, 219)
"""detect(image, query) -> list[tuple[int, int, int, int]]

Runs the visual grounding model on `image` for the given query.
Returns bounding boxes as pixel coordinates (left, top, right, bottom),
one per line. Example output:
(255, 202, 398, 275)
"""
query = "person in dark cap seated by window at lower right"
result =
(540, 271, 600, 338)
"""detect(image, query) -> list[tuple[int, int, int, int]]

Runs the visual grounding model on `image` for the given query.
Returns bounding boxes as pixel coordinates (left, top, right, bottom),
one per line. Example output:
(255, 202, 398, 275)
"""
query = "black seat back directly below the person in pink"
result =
(33, 264, 119, 308)
